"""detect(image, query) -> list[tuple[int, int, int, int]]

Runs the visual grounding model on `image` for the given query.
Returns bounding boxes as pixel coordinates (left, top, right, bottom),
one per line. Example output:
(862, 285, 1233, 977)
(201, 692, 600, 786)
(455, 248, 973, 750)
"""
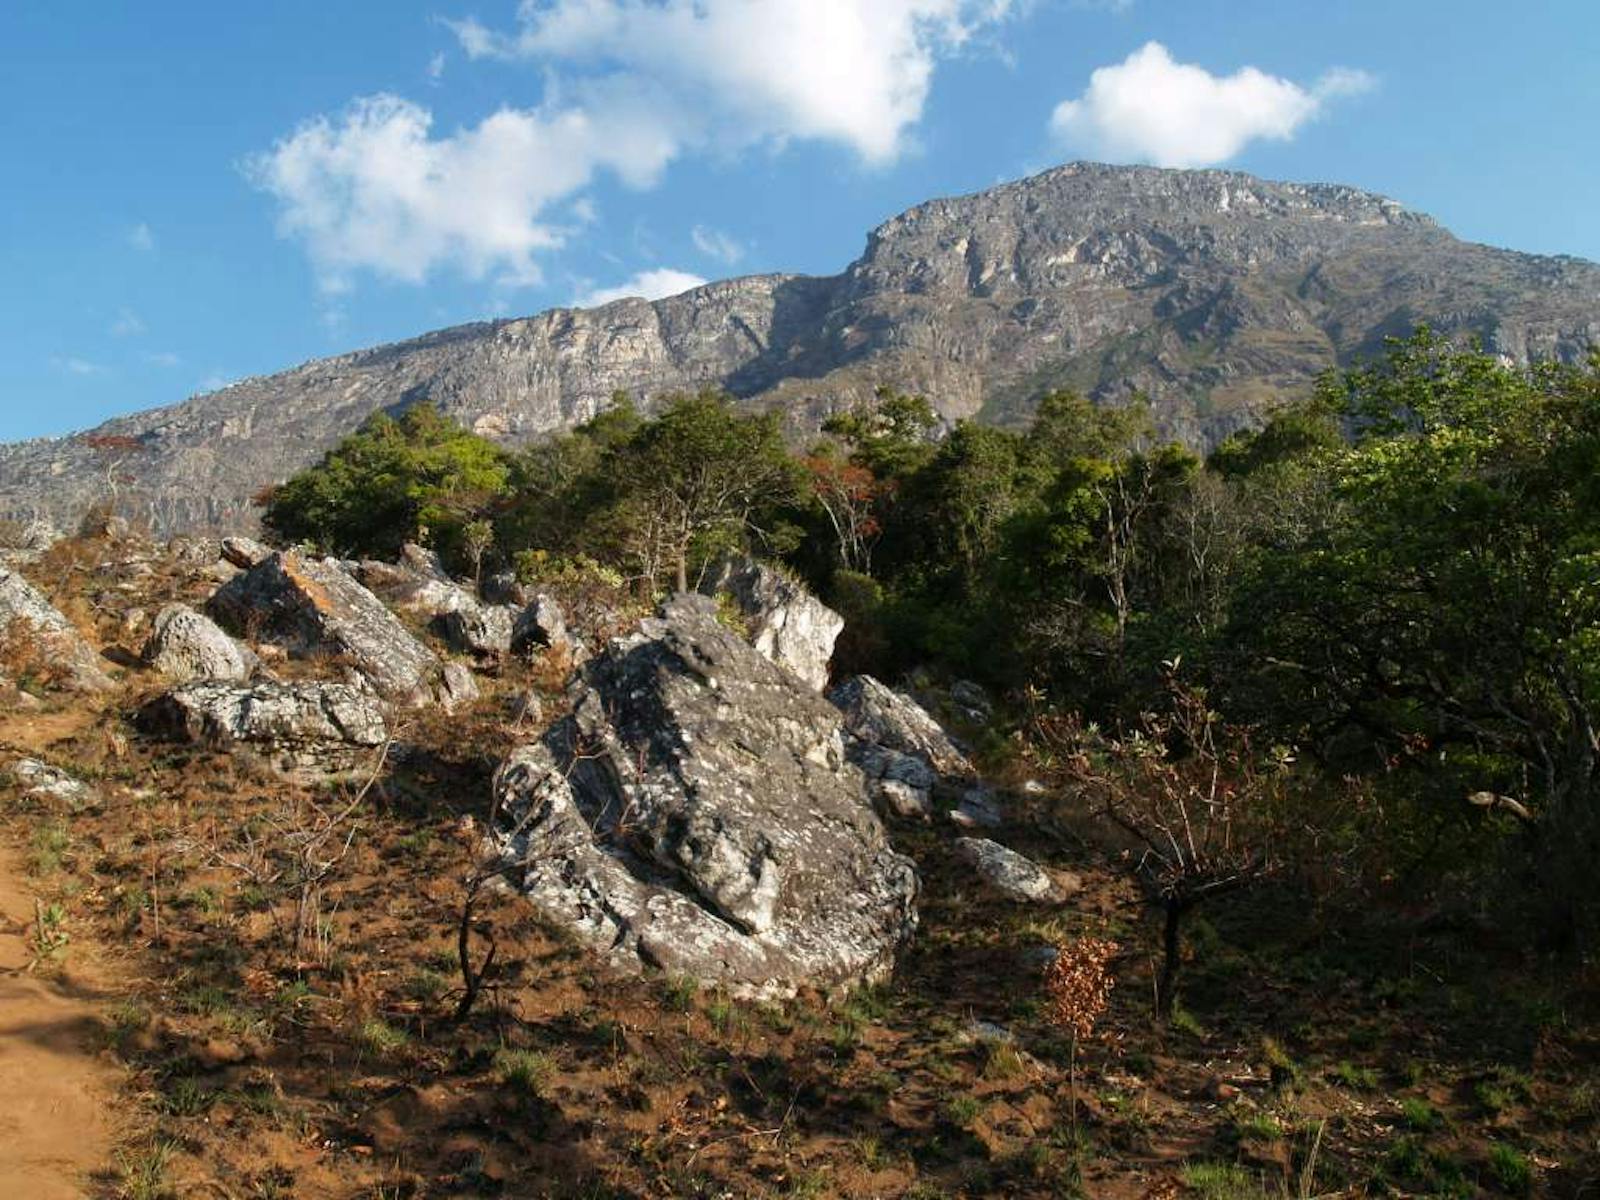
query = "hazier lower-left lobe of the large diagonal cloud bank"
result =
(245, 94, 677, 293)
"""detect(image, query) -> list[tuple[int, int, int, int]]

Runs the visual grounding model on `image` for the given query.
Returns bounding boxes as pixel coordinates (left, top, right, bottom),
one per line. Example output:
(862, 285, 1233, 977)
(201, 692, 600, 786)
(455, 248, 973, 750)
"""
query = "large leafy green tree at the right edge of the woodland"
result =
(1227, 330, 1600, 933)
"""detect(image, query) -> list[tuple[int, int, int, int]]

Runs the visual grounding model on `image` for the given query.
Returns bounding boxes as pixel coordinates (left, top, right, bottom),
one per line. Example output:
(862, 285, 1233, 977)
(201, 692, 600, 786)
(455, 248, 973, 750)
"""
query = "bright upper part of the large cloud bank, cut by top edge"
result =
(451, 0, 1013, 163)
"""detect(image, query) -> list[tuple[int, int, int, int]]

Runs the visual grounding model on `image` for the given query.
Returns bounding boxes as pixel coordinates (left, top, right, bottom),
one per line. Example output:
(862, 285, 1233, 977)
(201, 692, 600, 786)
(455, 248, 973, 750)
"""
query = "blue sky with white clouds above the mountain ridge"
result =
(0, 0, 1600, 440)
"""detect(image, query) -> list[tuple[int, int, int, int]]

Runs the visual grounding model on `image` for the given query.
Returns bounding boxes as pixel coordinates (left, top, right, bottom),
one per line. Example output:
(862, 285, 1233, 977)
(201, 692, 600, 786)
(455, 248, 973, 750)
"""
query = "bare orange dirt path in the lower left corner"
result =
(0, 846, 118, 1200)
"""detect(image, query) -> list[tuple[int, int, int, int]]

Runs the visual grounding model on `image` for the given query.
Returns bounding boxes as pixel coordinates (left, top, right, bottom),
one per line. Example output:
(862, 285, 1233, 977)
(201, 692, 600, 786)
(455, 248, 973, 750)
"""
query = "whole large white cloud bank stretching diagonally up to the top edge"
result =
(245, 0, 1004, 294)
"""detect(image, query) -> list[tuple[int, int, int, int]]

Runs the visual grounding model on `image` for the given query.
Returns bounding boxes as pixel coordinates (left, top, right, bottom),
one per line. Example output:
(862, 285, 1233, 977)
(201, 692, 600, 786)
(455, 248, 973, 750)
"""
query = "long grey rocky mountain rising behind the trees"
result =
(0, 163, 1600, 533)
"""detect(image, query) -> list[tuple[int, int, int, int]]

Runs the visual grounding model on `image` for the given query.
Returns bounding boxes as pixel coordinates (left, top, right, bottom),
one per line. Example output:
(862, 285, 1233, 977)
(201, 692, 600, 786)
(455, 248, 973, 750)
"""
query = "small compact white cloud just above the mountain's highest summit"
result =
(1050, 42, 1374, 166)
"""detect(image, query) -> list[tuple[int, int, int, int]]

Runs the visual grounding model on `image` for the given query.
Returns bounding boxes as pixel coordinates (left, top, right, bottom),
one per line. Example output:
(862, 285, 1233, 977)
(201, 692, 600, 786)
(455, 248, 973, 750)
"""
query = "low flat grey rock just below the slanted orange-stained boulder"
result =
(138, 680, 389, 771)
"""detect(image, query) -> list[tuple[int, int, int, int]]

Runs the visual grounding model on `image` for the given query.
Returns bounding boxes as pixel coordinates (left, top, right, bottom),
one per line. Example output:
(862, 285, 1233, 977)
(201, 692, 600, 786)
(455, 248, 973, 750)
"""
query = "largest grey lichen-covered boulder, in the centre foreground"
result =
(496, 595, 918, 995)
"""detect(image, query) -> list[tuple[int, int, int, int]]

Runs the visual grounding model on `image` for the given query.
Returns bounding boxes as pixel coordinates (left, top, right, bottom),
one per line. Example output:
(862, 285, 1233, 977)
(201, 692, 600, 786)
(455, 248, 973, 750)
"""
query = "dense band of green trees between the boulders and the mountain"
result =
(267, 331, 1600, 944)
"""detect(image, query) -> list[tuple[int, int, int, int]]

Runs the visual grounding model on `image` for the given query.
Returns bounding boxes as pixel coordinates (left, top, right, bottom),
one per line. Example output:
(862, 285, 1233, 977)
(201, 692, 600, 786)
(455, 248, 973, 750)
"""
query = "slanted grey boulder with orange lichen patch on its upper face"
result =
(206, 550, 440, 704)
